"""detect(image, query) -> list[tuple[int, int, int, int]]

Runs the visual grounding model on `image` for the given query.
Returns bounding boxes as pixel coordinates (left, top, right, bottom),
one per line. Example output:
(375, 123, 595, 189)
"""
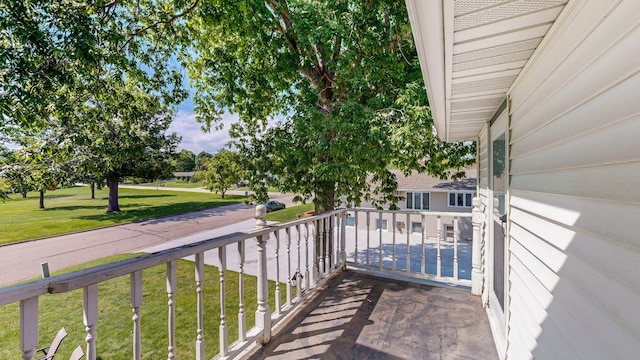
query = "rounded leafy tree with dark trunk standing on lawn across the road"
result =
(78, 83, 180, 212)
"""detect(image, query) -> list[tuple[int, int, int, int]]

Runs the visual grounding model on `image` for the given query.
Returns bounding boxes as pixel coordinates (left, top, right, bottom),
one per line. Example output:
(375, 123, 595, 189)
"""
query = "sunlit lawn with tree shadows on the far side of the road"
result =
(0, 186, 245, 244)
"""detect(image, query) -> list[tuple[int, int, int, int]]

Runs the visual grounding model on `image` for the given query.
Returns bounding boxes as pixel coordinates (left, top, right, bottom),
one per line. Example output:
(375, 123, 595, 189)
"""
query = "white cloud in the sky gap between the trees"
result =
(169, 110, 238, 154)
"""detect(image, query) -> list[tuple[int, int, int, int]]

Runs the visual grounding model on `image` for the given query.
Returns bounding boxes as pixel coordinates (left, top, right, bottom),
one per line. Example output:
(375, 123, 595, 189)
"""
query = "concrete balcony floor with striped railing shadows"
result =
(250, 271, 498, 360)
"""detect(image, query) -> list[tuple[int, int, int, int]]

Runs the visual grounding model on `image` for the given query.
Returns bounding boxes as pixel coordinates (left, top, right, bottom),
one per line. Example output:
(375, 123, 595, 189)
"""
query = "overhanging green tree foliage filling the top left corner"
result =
(0, 0, 192, 129)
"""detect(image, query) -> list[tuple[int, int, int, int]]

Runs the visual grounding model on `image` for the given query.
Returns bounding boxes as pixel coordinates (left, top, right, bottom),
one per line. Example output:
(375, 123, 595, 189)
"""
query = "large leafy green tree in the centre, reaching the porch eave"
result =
(186, 0, 474, 210)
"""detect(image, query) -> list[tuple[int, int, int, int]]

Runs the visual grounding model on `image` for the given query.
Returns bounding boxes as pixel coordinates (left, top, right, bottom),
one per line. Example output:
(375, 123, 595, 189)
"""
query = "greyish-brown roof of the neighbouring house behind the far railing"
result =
(391, 167, 478, 191)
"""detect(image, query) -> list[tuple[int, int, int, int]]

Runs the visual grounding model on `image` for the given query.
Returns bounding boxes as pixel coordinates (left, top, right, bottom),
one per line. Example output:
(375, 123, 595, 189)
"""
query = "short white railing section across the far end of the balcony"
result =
(346, 209, 473, 287)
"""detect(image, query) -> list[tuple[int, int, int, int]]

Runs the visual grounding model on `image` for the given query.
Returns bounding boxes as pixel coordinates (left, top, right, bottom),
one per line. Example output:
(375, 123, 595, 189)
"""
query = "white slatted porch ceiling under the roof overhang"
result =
(405, 0, 568, 141)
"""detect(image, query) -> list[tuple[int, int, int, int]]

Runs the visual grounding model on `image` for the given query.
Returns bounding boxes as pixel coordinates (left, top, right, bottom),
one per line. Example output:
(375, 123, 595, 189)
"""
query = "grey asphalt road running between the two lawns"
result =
(0, 187, 293, 287)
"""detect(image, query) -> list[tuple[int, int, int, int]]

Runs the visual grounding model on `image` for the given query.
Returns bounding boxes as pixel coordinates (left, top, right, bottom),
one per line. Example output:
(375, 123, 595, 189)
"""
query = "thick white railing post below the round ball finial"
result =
(256, 234, 271, 345)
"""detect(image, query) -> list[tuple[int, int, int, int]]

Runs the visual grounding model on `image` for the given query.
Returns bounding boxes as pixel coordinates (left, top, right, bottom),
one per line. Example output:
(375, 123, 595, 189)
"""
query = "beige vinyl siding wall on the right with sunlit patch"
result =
(504, 0, 640, 359)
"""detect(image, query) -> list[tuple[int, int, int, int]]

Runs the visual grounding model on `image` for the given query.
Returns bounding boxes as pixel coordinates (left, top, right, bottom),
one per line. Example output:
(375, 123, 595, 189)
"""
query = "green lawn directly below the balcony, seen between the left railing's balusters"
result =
(0, 255, 285, 360)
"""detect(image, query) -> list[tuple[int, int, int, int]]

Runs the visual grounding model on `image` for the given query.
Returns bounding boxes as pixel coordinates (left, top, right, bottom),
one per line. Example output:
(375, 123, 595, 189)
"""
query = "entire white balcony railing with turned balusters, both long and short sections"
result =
(0, 201, 480, 360)
